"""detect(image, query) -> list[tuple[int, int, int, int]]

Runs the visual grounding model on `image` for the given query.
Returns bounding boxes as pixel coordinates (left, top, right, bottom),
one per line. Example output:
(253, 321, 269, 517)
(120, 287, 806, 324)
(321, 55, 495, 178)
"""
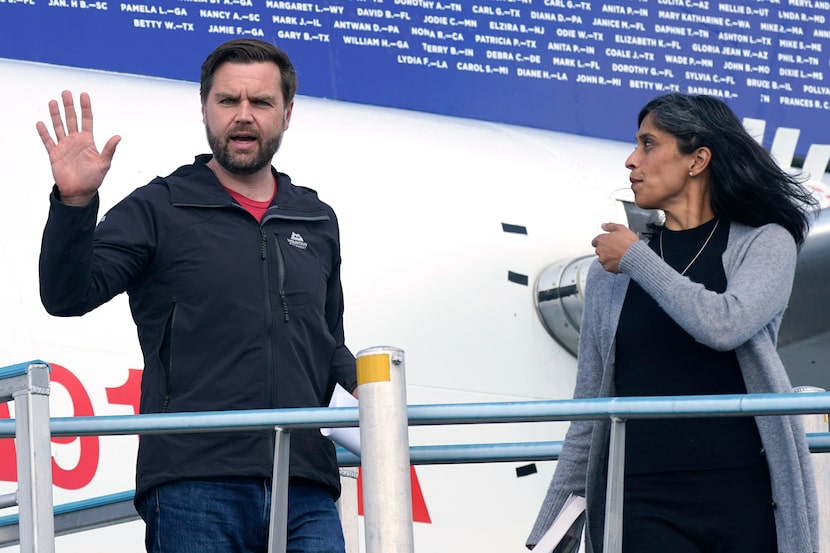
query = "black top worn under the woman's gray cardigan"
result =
(615, 219, 763, 474)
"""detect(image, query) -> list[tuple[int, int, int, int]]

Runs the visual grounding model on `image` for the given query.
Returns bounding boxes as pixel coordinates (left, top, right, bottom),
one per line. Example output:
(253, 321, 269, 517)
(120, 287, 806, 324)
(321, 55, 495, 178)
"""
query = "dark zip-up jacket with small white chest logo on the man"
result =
(40, 155, 357, 497)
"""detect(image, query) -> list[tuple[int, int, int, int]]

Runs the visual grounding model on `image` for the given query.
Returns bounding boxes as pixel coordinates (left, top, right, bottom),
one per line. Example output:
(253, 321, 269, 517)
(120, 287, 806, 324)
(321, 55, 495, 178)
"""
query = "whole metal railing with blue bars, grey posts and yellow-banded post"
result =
(0, 356, 830, 553)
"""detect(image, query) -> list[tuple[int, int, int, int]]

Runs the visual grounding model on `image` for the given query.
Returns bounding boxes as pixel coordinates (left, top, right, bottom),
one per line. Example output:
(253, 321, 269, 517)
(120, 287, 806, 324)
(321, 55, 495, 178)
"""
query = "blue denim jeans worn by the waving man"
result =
(136, 478, 346, 553)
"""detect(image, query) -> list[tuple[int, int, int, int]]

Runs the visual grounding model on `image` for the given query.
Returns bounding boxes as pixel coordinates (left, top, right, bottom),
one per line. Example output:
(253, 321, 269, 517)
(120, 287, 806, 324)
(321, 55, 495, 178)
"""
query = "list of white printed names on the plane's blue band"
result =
(8, 0, 830, 132)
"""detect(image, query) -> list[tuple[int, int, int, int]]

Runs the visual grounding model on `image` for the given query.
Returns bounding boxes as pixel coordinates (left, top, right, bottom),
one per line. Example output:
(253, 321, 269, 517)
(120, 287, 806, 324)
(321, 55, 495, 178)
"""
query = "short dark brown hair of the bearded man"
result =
(199, 38, 297, 106)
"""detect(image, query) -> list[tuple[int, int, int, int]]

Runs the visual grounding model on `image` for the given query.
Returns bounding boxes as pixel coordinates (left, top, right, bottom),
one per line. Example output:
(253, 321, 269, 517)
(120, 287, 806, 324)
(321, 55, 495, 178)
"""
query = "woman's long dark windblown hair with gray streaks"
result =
(637, 93, 818, 247)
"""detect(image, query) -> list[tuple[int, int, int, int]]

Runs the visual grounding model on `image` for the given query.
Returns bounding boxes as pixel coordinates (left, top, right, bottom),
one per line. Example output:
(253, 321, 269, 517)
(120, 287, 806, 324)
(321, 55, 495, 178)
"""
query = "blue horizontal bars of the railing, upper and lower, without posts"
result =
(0, 392, 830, 540)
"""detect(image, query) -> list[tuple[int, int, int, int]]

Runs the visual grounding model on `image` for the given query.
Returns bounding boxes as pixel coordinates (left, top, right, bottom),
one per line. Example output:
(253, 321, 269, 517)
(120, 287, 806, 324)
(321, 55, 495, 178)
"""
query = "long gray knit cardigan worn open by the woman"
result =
(527, 222, 819, 553)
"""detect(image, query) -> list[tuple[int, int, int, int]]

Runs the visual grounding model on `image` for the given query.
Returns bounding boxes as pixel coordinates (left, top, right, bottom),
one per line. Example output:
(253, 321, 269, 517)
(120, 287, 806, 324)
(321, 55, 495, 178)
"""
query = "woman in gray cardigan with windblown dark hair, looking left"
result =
(528, 94, 818, 553)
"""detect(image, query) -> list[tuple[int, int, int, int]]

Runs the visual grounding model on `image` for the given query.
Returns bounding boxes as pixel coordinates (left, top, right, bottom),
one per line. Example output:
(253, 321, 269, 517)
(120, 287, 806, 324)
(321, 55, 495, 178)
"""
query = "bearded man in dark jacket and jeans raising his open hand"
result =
(37, 39, 356, 553)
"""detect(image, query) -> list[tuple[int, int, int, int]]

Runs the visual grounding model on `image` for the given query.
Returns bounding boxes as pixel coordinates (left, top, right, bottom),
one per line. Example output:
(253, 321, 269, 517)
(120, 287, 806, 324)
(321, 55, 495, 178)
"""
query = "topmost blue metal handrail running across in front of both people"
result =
(0, 392, 830, 438)
